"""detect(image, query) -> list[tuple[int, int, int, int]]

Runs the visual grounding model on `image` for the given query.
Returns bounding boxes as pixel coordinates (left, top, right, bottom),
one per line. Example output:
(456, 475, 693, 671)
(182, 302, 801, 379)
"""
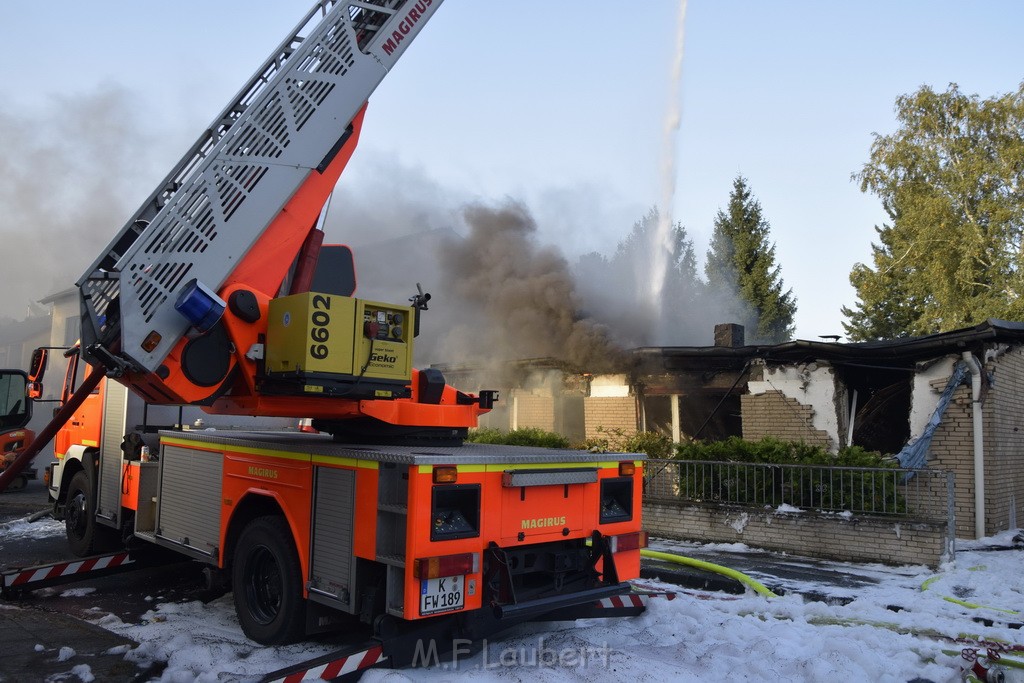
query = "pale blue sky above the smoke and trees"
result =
(0, 0, 1024, 339)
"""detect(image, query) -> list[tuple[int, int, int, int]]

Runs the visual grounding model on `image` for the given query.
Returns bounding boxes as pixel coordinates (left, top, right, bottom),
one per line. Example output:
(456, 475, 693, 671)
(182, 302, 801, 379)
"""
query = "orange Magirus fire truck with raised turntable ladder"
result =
(0, 0, 646, 661)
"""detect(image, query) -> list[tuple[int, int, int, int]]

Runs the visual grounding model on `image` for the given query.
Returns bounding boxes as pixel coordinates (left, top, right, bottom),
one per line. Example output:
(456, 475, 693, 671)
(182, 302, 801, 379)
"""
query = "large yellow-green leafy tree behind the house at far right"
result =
(843, 83, 1024, 340)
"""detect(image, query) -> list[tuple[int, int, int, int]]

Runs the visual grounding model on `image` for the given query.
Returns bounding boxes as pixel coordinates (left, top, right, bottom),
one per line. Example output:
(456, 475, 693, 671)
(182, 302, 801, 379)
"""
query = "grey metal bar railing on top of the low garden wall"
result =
(644, 460, 955, 529)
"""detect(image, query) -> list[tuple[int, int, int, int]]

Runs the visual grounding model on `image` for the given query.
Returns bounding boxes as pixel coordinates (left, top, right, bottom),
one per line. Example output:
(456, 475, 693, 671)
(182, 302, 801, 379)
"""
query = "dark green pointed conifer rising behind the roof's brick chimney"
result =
(705, 176, 797, 343)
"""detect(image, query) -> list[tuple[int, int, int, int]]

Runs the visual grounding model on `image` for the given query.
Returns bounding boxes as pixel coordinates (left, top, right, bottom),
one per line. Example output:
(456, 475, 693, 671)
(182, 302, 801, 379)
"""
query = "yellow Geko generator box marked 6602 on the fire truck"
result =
(264, 292, 416, 398)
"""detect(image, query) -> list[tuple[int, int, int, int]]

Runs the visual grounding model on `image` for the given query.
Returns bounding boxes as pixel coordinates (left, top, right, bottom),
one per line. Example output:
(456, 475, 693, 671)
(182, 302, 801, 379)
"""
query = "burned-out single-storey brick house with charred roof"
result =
(442, 319, 1024, 538)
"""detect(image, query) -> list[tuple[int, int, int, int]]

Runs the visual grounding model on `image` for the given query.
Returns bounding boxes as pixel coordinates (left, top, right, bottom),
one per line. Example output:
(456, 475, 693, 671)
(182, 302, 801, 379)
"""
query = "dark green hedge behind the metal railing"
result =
(676, 437, 906, 512)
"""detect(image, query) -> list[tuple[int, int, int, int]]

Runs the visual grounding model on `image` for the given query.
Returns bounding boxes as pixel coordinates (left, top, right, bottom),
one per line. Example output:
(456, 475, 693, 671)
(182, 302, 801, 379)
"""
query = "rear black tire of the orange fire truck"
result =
(231, 515, 306, 645)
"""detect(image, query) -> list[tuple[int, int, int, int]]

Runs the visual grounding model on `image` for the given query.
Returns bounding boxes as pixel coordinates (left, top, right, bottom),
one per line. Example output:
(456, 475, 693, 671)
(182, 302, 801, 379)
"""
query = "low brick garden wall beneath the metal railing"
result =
(643, 502, 951, 567)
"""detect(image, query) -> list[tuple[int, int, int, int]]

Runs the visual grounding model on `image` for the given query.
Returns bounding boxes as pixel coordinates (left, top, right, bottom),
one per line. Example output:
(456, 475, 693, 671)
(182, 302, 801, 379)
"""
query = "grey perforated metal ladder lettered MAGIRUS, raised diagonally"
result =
(77, 0, 441, 372)
